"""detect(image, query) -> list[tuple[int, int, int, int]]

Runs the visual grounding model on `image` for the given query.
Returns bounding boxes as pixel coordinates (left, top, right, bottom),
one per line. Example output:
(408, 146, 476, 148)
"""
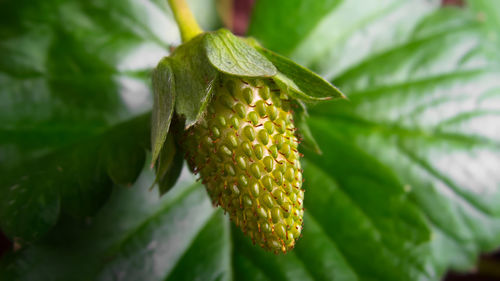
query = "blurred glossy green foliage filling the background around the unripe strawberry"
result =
(0, 0, 500, 280)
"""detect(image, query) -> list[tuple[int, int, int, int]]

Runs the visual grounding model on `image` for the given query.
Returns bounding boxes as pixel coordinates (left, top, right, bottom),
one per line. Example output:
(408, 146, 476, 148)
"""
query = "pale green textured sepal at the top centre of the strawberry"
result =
(203, 29, 276, 77)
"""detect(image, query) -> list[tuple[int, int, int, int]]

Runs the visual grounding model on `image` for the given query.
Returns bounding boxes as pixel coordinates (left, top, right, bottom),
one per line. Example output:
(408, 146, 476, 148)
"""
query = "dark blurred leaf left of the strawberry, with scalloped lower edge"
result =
(0, 0, 216, 241)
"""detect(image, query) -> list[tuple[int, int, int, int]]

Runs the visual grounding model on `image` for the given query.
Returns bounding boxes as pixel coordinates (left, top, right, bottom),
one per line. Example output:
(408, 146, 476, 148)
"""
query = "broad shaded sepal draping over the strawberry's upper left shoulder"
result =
(170, 33, 218, 129)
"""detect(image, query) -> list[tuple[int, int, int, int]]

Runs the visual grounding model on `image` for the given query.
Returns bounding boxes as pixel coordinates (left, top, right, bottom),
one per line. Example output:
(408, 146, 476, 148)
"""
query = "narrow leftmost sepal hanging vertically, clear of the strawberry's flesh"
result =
(151, 57, 176, 164)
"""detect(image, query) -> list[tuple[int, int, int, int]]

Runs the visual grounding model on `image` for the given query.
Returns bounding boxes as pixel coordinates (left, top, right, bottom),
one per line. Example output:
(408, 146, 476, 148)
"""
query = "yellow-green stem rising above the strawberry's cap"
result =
(168, 0, 203, 42)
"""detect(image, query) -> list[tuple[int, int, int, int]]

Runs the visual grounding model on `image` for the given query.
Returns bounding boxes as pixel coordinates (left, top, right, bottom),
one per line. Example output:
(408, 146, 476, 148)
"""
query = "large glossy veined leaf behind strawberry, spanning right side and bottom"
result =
(0, 0, 500, 281)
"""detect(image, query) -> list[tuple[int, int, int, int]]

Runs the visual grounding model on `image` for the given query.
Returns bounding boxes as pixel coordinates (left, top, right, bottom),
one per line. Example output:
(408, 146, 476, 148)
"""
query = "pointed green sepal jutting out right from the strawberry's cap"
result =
(252, 39, 346, 102)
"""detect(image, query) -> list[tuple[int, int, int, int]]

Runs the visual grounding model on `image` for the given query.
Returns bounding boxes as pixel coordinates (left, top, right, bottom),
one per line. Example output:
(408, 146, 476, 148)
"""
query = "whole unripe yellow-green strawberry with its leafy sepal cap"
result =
(151, 23, 344, 253)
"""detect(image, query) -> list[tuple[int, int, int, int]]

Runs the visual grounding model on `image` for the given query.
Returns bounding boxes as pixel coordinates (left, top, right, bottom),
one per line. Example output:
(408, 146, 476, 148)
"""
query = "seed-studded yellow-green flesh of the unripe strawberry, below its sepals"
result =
(182, 77, 304, 252)
